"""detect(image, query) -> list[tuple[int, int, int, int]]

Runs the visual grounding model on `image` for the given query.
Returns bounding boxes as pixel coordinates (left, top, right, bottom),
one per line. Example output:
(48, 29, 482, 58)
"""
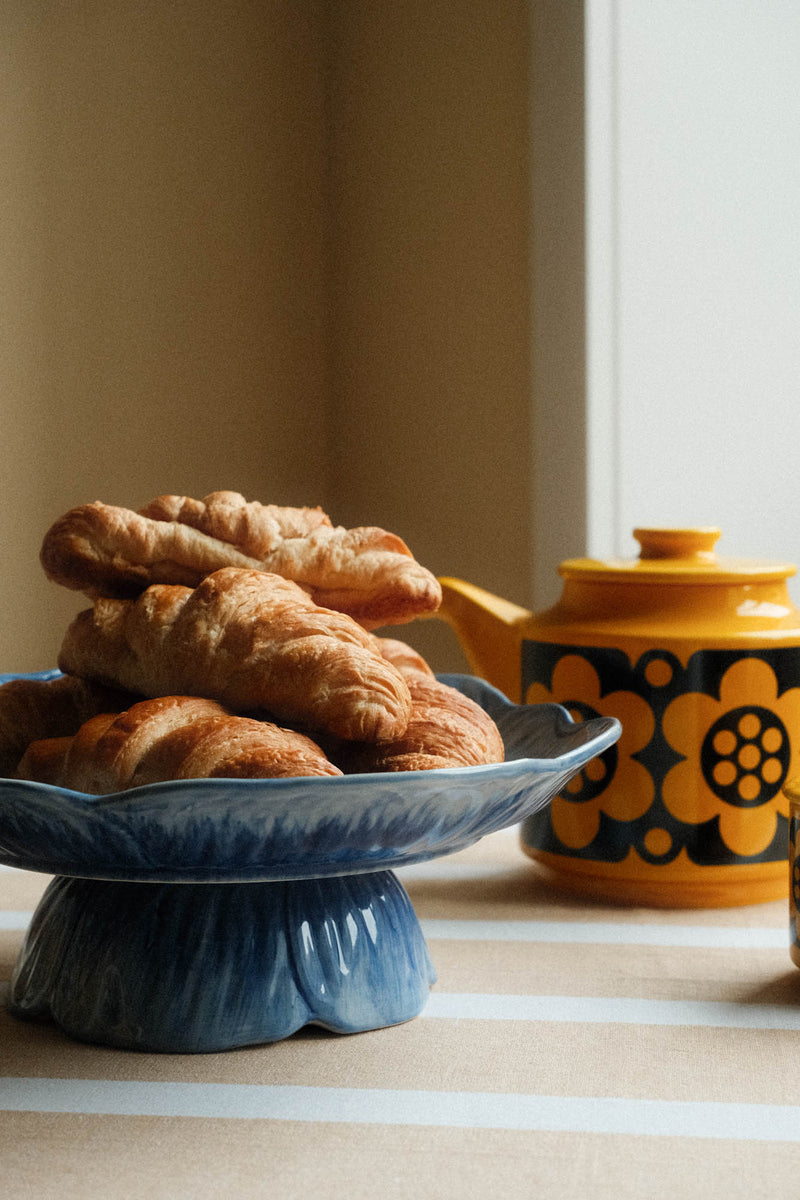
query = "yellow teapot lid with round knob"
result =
(559, 526, 796, 583)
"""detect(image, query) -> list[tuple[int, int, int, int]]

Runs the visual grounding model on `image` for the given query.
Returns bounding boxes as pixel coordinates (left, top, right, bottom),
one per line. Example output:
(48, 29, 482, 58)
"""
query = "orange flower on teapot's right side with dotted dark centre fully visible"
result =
(663, 658, 800, 857)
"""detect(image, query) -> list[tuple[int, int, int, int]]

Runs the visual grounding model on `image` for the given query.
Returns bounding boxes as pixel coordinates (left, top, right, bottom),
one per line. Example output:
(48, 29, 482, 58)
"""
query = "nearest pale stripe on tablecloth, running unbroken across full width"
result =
(0, 1078, 800, 1141)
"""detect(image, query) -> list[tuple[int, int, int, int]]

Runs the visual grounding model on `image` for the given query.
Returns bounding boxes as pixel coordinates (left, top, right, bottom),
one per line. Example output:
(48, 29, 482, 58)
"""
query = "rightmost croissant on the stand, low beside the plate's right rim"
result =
(331, 672, 505, 774)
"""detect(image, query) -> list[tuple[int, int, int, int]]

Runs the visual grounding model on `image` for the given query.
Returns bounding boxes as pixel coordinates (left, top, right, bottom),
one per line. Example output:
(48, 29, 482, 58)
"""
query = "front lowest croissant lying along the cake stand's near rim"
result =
(17, 696, 341, 796)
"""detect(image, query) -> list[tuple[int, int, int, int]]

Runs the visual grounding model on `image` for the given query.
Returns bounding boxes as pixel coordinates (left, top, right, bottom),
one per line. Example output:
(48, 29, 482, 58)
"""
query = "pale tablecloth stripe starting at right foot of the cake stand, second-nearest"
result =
(421, 991, 800, 1031)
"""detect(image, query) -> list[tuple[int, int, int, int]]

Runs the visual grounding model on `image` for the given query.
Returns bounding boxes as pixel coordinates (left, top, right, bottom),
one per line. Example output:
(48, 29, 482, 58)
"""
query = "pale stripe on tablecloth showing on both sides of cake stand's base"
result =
(0, 908, 789, 953)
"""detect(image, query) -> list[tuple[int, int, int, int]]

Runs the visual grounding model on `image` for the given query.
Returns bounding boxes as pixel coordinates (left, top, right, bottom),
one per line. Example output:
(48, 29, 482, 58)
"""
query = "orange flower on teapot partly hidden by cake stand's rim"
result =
(525, 654, 655, 850)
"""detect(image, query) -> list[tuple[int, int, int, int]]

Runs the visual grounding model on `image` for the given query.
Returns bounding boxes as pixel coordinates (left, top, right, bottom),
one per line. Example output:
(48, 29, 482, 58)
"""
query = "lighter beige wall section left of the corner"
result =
(0, 0, 329, 670)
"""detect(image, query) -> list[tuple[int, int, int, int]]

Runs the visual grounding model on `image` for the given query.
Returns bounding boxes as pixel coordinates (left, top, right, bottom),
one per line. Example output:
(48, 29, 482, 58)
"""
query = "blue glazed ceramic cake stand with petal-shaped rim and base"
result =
(0, 672, 620, 1054)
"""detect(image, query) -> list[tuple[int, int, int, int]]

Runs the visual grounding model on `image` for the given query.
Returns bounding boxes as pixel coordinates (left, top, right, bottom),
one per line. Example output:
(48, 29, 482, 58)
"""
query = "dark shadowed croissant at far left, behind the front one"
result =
(0, 676, 136, 776)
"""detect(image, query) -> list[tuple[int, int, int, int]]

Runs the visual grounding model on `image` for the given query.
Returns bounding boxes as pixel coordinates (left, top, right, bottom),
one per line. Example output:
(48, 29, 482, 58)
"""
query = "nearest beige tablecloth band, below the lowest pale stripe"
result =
(2, 1114, 800, 1200)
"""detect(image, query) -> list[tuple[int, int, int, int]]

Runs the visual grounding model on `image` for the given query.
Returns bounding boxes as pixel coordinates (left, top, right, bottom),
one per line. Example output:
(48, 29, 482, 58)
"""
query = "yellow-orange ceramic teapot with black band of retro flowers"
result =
(439, 528, 800, 907)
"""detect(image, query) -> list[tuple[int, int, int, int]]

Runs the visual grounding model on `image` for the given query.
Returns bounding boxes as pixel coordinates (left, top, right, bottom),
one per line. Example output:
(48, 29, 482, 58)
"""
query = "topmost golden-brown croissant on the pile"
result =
(40, 492, 441, 629)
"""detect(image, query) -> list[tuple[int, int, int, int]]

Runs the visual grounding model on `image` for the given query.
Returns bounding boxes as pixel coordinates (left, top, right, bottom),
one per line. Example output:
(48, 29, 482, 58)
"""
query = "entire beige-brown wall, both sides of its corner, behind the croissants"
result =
(0, 0, 531, 670)
